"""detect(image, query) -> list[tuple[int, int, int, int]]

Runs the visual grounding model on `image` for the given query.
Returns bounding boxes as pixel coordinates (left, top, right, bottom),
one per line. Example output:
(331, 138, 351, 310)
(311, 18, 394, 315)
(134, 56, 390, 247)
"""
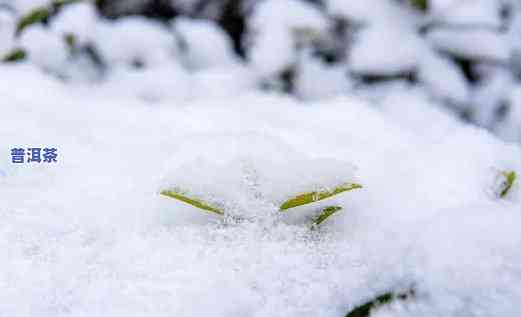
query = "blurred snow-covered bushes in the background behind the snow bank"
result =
(0, 0, 521, 143)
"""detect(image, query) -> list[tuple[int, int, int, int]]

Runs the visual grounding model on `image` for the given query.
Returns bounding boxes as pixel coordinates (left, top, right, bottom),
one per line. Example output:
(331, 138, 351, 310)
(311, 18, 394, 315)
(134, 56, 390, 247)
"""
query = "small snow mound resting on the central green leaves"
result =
(164, 135, 356, 216)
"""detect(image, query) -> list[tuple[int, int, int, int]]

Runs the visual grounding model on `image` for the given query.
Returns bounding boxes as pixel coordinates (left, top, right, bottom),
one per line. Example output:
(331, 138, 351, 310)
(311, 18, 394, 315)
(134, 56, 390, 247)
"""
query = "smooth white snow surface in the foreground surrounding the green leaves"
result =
(0, 64, 521, 317)
